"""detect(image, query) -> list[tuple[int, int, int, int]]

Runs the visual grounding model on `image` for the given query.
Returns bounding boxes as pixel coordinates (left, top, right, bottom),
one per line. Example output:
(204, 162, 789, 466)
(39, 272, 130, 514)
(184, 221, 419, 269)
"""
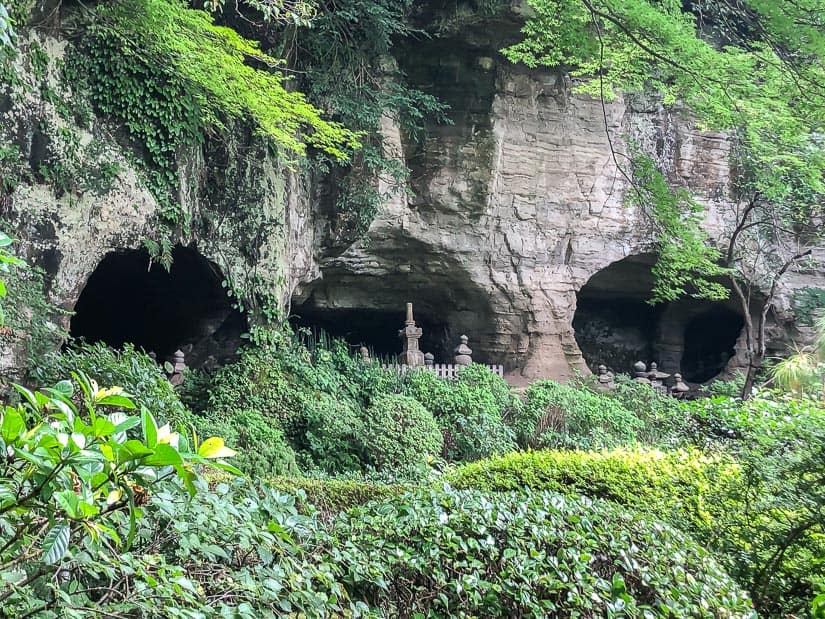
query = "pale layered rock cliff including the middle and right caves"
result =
(293, 19, 823, 382)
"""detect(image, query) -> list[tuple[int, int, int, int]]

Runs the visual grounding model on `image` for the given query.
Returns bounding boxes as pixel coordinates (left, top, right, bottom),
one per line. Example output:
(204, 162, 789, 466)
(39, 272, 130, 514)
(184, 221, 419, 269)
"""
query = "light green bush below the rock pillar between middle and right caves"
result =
(514, 380, 643, 449)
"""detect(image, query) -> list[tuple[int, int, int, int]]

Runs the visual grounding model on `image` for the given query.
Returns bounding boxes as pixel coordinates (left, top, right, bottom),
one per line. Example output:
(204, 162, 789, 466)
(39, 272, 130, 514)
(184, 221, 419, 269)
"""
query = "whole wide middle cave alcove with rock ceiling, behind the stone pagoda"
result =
(290, 237, 504, 363)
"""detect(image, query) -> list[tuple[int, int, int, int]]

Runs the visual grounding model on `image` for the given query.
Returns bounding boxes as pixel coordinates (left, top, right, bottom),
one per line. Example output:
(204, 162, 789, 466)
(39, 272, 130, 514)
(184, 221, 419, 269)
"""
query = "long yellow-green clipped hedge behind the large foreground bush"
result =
(445, 448, 740, 539)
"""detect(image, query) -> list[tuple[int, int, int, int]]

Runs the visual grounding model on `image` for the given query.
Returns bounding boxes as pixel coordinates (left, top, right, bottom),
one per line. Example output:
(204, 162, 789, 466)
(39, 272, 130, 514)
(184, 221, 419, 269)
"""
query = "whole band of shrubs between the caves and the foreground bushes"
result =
(20, 332, 825, 616)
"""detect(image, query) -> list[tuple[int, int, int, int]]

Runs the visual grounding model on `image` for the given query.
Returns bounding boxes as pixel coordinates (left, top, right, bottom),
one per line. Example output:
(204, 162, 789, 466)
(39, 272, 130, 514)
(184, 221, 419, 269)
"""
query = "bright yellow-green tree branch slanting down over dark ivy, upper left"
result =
(90, 0, 360, 160)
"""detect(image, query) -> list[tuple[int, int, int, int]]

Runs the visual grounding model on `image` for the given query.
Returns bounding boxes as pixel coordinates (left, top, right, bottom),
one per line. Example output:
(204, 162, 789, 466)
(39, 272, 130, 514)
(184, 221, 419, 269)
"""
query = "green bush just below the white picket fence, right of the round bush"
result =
(402, 364, 518, 460)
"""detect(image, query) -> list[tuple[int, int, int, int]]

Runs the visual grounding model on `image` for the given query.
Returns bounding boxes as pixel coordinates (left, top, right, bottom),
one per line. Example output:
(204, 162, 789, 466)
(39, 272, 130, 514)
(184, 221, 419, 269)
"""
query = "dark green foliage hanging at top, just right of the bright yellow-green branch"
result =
(241, 0, 445, 237)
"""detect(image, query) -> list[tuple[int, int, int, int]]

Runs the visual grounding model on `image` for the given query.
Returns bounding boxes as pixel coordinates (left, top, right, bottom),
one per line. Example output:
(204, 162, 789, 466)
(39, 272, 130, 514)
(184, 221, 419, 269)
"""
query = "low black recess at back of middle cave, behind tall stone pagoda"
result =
(289, 304, 457, 362)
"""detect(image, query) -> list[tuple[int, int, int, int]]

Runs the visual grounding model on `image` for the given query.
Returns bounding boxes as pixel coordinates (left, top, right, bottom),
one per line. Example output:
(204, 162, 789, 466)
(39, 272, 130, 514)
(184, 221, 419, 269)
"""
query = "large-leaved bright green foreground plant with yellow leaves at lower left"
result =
(0, 374, 234, 616)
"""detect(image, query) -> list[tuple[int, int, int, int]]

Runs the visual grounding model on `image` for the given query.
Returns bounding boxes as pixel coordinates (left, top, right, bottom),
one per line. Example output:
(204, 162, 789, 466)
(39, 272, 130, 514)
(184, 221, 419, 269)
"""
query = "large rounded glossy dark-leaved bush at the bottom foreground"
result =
(332, 487, 755, 619)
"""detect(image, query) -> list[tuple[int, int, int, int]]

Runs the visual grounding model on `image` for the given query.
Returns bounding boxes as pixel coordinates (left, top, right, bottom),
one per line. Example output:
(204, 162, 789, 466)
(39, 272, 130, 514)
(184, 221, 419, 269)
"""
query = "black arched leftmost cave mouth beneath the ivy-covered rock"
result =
(70, 245, 248, 367)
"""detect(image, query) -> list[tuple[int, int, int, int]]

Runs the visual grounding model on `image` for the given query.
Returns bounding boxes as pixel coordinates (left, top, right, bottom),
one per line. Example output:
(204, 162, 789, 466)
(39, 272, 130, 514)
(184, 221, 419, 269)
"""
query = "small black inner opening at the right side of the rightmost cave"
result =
(682, 306, 745, 383)
